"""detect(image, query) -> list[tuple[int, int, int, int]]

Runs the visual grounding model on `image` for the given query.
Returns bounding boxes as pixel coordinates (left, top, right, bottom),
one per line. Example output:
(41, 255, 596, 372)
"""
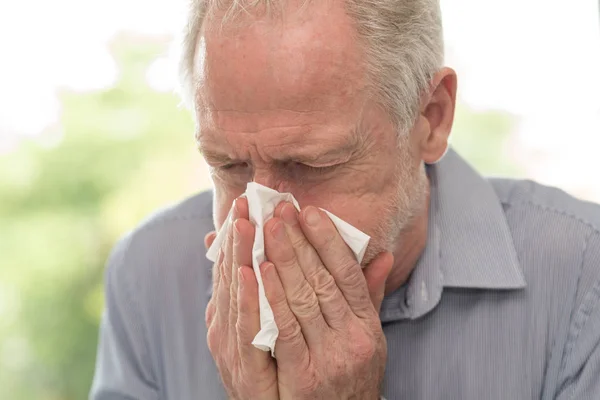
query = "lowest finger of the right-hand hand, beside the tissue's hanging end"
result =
(260, 262, 309, 371)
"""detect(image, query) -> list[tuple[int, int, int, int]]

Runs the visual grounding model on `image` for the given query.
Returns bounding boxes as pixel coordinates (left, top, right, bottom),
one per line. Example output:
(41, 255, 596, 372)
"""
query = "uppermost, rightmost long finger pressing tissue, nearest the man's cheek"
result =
(299, 206, 372, 318)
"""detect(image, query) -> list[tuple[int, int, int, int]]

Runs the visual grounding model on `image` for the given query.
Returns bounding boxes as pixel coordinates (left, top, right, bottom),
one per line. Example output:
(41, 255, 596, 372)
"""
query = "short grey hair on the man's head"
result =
(180, 0, 444, 132)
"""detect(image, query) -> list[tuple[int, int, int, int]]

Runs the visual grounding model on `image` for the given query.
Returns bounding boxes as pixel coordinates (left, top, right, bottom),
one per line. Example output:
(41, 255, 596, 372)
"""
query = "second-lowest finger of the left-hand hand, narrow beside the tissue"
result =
(229, 218, 254, 342)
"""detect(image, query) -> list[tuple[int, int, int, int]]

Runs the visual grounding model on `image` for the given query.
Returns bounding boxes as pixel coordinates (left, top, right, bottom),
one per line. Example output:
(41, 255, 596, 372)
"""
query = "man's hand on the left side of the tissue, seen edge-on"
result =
(204, 198, 279, 400)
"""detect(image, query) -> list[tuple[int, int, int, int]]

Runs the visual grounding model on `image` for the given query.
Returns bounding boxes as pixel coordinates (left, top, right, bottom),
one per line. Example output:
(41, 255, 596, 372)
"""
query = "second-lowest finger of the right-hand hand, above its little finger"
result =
(264, 218, 327, 345)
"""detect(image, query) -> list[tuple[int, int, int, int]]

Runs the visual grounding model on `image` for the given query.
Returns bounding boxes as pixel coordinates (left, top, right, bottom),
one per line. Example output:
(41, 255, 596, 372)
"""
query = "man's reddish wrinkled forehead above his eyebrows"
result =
(194, 1, 365, 112)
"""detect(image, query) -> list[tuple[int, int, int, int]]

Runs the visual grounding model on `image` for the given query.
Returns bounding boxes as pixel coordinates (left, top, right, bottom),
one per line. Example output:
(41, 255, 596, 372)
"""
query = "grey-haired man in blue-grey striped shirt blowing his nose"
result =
(91, 0, 600, 400)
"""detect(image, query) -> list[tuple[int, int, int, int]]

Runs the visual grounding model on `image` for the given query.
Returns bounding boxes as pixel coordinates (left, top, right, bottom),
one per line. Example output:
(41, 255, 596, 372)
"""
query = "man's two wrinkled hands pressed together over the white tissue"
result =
(206, 199, 393, 399)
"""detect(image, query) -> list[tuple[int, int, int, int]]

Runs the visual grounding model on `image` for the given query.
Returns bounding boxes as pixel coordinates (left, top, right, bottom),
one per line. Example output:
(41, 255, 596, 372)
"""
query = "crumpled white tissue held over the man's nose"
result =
(206, 182, 371, 357)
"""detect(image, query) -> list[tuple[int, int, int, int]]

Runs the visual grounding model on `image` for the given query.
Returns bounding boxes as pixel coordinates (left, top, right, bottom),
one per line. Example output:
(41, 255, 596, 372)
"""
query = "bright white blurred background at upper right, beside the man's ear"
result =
(442, 0, 600, 201)
